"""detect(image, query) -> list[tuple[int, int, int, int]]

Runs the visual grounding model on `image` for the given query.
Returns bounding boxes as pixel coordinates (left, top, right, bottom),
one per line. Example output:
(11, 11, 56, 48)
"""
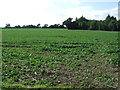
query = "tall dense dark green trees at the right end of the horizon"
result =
(63, 15, 120, 31)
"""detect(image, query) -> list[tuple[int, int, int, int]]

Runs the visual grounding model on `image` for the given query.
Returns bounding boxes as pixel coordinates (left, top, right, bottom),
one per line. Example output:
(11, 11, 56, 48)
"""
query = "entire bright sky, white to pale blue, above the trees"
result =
(0, 0, 119, 27)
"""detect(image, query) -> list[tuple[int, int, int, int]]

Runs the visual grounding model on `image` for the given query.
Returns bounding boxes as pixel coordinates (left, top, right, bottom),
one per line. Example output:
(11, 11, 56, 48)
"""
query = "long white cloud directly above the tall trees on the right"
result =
(55, 6, 118, 20)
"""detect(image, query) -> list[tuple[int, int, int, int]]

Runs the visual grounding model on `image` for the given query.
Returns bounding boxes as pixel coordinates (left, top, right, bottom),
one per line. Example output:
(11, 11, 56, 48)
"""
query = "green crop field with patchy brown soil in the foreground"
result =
(2, 29, 120, 88)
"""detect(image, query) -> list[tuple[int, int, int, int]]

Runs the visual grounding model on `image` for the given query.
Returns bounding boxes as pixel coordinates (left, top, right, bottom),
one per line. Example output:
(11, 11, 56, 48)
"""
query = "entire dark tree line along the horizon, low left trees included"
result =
(5, 15, 120, 31)
